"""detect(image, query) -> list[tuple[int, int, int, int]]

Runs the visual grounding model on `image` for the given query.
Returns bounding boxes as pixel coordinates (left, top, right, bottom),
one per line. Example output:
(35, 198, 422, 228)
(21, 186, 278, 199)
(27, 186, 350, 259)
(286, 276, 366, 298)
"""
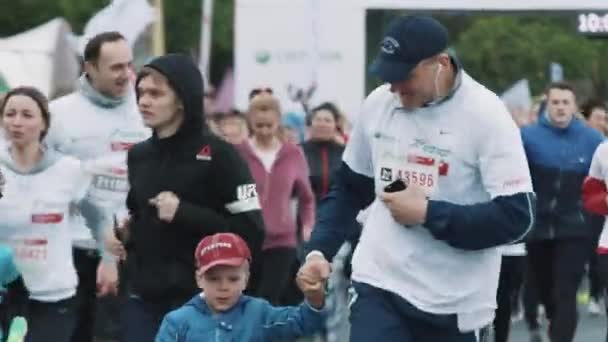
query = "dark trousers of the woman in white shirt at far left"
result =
(25, 298, 76, 342)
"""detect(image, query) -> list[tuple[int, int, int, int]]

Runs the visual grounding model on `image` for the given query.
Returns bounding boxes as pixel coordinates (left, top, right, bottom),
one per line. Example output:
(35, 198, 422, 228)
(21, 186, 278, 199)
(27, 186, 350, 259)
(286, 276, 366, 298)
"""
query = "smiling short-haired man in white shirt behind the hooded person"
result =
(46, 32, 150, 342)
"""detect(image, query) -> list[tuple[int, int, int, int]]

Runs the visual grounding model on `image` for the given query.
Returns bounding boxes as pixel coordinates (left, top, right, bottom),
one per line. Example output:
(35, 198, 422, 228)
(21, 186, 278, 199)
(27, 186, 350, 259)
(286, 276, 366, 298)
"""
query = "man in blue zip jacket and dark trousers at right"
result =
(521, 82, 603, 342)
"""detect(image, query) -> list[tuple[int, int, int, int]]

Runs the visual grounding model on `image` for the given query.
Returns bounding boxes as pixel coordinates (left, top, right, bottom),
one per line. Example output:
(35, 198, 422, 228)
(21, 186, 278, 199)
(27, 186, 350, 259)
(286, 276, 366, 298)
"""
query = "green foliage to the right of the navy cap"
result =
(455, 16, 606, 93)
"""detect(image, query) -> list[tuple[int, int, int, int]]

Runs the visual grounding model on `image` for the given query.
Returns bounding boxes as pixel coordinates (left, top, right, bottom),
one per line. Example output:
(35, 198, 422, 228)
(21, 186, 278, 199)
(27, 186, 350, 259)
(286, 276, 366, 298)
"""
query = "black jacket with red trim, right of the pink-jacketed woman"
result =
(302, 140, 344, 208)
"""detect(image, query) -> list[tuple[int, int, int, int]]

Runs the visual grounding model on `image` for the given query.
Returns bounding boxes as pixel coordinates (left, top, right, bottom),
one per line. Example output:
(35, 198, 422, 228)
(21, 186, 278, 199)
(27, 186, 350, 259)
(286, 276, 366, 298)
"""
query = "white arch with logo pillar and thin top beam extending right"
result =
(235, 0, 608, 114)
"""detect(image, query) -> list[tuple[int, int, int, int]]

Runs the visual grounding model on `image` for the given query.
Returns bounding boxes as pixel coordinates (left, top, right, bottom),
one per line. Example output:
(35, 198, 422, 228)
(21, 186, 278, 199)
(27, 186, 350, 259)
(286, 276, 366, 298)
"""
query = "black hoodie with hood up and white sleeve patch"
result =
(126, 54, 264, 302)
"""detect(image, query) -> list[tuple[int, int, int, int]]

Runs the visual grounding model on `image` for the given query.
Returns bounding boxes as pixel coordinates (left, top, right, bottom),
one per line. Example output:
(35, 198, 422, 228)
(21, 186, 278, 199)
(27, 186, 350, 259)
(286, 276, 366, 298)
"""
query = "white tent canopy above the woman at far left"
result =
(0, 18, 79, 97)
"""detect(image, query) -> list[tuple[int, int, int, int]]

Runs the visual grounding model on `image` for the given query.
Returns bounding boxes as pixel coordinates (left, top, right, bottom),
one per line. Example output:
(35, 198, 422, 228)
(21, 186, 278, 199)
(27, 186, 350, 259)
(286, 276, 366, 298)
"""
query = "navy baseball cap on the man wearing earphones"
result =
(370, 16, 448, 83)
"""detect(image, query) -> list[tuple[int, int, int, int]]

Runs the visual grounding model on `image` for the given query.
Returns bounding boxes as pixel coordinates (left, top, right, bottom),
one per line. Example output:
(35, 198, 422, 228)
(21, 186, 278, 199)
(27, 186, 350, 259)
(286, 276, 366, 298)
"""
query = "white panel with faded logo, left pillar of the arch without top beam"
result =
(234, 0, 365, 114)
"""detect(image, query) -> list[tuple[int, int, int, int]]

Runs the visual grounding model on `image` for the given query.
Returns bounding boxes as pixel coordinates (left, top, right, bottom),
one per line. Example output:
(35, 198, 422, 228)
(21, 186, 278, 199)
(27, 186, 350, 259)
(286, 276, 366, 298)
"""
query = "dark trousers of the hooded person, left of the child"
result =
(120, 296, 188, 342)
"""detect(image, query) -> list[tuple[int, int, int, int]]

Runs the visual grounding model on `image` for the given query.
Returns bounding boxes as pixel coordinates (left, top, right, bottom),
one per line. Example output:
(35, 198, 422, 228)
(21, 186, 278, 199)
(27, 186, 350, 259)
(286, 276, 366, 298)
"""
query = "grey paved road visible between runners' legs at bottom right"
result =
(509, 308, 606, 342)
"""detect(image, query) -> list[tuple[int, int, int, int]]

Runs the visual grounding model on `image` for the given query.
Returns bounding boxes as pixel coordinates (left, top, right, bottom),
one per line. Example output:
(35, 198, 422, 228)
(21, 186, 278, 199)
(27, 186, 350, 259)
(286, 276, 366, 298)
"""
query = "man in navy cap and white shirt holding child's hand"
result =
(300, 16, 534, 342)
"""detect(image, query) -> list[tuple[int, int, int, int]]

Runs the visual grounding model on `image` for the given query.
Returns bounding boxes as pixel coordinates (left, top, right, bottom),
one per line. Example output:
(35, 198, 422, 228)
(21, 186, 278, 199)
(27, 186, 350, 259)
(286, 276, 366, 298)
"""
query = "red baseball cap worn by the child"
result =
(194, 233, 251, 273)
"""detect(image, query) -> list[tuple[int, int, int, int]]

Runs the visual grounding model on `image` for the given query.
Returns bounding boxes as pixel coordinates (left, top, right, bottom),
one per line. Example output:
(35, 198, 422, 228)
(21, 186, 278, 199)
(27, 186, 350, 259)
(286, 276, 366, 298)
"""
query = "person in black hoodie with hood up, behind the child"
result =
(121, 54, 264, 342)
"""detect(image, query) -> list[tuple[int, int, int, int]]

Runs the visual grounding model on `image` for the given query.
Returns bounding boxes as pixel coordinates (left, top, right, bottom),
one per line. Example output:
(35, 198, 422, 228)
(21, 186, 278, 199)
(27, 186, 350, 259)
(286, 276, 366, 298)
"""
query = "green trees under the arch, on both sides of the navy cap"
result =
(366, 10, 608, 98)
